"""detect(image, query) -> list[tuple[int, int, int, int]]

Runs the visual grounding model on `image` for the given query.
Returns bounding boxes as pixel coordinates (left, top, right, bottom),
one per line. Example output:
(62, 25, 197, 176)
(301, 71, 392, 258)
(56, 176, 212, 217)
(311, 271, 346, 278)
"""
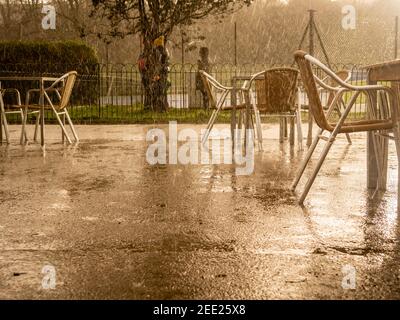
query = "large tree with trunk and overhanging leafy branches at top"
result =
(92, 0, 253, 111)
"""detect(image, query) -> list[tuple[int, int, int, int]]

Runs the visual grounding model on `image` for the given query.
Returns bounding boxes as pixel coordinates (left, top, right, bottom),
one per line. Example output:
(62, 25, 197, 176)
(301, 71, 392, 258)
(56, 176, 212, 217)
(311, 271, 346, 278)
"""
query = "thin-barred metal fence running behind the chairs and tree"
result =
(0, 64, 367, 123)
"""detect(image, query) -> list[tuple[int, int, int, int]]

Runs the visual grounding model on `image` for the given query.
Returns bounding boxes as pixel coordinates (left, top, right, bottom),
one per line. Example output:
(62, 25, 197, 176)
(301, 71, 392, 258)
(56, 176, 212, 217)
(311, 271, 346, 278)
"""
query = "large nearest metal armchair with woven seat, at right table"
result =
(291, 51, 400, 204)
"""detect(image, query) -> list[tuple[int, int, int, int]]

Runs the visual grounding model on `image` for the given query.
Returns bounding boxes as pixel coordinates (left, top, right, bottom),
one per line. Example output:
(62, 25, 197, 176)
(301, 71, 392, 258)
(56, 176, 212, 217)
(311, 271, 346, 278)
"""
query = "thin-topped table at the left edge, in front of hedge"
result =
(0, 76, 58, 147)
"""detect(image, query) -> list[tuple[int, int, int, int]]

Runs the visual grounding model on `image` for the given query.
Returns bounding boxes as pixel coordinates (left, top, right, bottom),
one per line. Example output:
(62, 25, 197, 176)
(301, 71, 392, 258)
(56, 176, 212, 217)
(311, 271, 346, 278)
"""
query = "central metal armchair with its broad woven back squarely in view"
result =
(241, 68, 303, 149)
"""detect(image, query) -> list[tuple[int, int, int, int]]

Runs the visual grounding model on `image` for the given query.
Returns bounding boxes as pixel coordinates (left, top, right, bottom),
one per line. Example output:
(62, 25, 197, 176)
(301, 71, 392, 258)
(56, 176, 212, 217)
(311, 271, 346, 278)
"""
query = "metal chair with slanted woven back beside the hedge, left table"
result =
(10, 71, 79, 144)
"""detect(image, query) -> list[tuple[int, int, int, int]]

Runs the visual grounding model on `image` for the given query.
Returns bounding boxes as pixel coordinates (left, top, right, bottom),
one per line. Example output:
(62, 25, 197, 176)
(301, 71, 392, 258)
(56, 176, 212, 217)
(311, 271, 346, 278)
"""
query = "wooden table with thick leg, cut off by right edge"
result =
(364, 60, 400, 190)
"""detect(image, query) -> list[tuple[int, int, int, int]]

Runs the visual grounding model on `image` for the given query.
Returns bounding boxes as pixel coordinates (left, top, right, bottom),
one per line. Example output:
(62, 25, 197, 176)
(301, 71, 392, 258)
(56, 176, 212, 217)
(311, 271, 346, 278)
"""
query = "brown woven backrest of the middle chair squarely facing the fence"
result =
(255, 68, 299, 114)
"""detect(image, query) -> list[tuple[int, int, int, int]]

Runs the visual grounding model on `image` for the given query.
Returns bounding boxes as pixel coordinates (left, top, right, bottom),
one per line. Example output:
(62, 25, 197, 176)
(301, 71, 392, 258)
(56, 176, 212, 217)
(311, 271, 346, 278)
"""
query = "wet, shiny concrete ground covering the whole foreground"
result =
(0, 124, 400, 299)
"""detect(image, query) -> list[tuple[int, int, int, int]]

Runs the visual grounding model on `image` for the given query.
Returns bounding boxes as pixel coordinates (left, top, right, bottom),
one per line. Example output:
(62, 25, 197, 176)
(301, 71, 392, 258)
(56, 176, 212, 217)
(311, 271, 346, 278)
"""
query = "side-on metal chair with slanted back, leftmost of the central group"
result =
(199, 70, 246, 145)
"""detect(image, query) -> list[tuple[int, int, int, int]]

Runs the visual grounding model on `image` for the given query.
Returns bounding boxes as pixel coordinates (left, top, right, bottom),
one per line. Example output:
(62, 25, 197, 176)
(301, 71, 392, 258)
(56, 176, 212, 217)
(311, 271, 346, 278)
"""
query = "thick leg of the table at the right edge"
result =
(367, 81, 389, 191)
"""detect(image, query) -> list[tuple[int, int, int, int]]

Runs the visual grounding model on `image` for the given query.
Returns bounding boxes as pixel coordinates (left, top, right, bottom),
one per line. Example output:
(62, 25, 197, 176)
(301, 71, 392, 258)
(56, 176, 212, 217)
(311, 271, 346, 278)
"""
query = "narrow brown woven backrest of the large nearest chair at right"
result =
(294, 50, 330, 130)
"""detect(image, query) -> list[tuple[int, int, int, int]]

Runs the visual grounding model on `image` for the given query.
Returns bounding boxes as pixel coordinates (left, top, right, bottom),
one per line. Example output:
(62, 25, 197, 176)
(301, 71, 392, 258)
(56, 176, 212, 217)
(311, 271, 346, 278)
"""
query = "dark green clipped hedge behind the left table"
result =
(0, 41, 99, 104)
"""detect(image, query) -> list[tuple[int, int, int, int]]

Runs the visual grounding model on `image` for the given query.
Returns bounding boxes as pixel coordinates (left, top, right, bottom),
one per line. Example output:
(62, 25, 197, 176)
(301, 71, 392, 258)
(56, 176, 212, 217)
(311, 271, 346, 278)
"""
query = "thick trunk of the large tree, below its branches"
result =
(139, 41, 170, 112)
